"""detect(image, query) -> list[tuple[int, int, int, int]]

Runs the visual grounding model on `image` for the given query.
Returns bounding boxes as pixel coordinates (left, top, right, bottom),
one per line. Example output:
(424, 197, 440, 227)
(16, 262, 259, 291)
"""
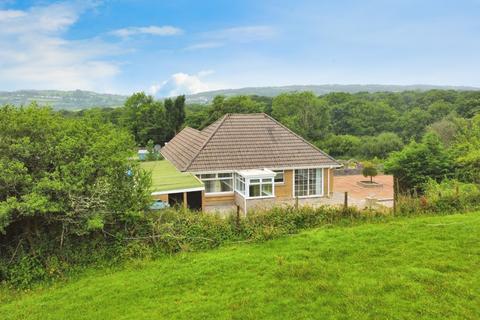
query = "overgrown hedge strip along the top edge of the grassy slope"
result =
(0, 176, 480, 288)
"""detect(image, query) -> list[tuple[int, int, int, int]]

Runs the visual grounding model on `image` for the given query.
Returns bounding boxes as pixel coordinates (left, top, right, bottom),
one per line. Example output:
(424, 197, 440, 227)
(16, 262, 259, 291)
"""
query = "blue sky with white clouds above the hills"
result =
(0, 0, 480, 97)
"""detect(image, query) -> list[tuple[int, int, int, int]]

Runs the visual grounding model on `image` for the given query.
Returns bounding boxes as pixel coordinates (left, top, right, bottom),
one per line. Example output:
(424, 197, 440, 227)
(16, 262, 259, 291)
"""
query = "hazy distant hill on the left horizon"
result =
(0, 90, 127, 110)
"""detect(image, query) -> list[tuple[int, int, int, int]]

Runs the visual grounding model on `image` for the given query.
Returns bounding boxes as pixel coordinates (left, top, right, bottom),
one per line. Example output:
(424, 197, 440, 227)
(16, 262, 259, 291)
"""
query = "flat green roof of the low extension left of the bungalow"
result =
(140, 160, 203, 192)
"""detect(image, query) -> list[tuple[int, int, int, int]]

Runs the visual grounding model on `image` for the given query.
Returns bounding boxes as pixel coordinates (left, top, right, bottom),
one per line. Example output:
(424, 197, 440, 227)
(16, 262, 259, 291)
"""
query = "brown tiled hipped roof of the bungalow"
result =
(161, 113, 339, 172)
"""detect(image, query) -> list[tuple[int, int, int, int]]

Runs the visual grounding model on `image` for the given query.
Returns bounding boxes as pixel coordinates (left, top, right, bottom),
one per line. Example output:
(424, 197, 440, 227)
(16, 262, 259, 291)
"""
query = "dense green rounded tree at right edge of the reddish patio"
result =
(384, 132, 453, 191)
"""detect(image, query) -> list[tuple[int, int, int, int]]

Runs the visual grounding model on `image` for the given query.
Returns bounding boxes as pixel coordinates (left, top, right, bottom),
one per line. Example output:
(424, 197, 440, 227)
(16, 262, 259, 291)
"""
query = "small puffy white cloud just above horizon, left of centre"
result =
(149, 70, 224, 97)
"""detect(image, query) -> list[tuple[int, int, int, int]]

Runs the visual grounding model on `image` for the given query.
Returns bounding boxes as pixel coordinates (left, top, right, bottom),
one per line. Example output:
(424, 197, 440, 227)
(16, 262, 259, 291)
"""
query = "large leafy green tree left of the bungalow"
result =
(0, 105, 150, 251)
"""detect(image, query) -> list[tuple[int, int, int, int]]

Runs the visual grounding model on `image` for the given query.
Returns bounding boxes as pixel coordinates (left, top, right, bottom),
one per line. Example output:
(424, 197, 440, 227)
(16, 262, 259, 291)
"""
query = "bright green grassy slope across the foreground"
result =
(0, 213, 480, 320)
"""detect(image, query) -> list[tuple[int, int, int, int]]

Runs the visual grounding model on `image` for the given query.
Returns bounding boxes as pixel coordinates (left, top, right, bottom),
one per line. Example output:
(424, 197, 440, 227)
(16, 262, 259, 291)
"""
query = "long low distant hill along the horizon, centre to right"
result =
(187, 84, 480, 103)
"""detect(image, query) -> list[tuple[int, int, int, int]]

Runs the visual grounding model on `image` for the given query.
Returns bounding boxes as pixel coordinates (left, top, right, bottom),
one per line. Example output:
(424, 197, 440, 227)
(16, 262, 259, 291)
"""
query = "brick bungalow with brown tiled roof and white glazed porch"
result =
(160, 113, 341, 213)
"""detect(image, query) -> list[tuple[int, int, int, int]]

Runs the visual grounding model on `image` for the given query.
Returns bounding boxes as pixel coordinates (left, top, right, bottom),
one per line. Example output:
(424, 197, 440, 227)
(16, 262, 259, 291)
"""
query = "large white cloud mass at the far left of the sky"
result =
(0, 2, 119, 91)
